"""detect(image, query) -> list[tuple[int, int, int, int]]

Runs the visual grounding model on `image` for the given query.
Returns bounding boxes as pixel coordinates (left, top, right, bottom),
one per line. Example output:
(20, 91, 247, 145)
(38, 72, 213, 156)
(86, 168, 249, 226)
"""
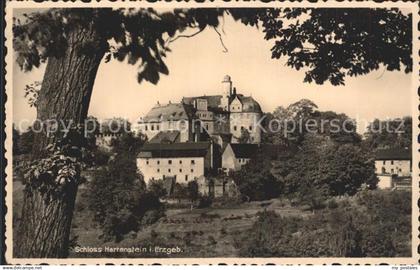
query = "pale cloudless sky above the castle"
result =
(13, 8, 413, 132)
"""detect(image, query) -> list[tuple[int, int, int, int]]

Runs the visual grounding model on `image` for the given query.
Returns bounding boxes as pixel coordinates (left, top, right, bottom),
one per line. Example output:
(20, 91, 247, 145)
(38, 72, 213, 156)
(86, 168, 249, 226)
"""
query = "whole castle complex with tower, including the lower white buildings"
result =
(134, 75, 263, 196)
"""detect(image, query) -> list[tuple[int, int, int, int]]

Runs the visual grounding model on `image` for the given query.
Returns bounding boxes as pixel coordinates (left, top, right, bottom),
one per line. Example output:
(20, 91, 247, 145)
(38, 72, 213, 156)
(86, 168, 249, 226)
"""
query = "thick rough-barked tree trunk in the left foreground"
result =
(15, 25, 107, 258)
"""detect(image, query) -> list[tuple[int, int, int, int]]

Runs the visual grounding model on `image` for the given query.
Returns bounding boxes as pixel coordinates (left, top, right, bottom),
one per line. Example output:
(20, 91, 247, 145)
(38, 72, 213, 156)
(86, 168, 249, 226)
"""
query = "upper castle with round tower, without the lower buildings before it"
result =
(136, 75, 262, 144)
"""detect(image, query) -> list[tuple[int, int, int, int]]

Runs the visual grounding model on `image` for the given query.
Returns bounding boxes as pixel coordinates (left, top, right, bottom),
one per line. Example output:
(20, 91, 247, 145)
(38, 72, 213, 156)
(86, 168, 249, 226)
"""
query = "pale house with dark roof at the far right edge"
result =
(375, 148, 412, 189)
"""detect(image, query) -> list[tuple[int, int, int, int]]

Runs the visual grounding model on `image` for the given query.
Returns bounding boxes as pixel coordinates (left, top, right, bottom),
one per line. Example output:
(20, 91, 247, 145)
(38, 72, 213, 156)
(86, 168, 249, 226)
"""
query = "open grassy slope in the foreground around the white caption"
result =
(70, 188, 309, 257)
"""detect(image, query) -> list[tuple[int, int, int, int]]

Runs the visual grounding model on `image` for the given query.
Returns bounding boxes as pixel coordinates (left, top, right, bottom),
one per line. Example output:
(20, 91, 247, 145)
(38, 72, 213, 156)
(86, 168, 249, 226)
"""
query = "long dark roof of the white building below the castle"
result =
(138, 142, 210, 158)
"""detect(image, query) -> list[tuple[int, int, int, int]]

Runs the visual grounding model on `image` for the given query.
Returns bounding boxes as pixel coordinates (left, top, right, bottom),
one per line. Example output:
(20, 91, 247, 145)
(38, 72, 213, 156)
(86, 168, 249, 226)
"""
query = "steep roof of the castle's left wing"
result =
(143, 103, 193, 122)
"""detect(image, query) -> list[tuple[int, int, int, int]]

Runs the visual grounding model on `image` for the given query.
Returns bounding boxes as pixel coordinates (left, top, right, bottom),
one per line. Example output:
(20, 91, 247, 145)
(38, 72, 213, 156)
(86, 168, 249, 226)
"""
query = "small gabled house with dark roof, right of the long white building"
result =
(222, 143, 259, 173)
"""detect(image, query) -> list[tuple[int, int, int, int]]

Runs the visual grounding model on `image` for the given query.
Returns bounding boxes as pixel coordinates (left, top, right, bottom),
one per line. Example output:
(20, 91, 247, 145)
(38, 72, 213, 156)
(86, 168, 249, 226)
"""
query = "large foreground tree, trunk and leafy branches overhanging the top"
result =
(13, 8, 412, 257)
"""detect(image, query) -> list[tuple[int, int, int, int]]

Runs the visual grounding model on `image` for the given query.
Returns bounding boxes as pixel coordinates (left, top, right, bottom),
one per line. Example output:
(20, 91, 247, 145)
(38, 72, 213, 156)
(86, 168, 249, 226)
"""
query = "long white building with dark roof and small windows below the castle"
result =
(137, 142, 213, 184)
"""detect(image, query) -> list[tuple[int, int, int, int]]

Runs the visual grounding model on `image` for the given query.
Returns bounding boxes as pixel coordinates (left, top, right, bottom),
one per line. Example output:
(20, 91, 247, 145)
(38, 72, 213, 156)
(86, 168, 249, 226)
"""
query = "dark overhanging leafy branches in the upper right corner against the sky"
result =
(230, 8, 412, 85)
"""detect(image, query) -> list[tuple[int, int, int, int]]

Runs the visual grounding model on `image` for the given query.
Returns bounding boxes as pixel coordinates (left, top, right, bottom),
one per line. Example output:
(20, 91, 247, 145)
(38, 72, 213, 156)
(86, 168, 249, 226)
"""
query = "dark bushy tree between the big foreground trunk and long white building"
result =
(88, 153, 164, 242)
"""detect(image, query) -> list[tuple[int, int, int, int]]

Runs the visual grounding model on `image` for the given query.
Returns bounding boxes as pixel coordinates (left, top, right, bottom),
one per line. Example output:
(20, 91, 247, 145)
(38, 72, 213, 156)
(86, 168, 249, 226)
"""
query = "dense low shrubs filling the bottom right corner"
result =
(235, 190, 411, 257)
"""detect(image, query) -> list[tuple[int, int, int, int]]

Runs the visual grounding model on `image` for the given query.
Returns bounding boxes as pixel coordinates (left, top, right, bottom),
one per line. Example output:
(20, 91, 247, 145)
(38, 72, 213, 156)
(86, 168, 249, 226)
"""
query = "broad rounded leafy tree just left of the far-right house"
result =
(274, 134, 377, 196)
